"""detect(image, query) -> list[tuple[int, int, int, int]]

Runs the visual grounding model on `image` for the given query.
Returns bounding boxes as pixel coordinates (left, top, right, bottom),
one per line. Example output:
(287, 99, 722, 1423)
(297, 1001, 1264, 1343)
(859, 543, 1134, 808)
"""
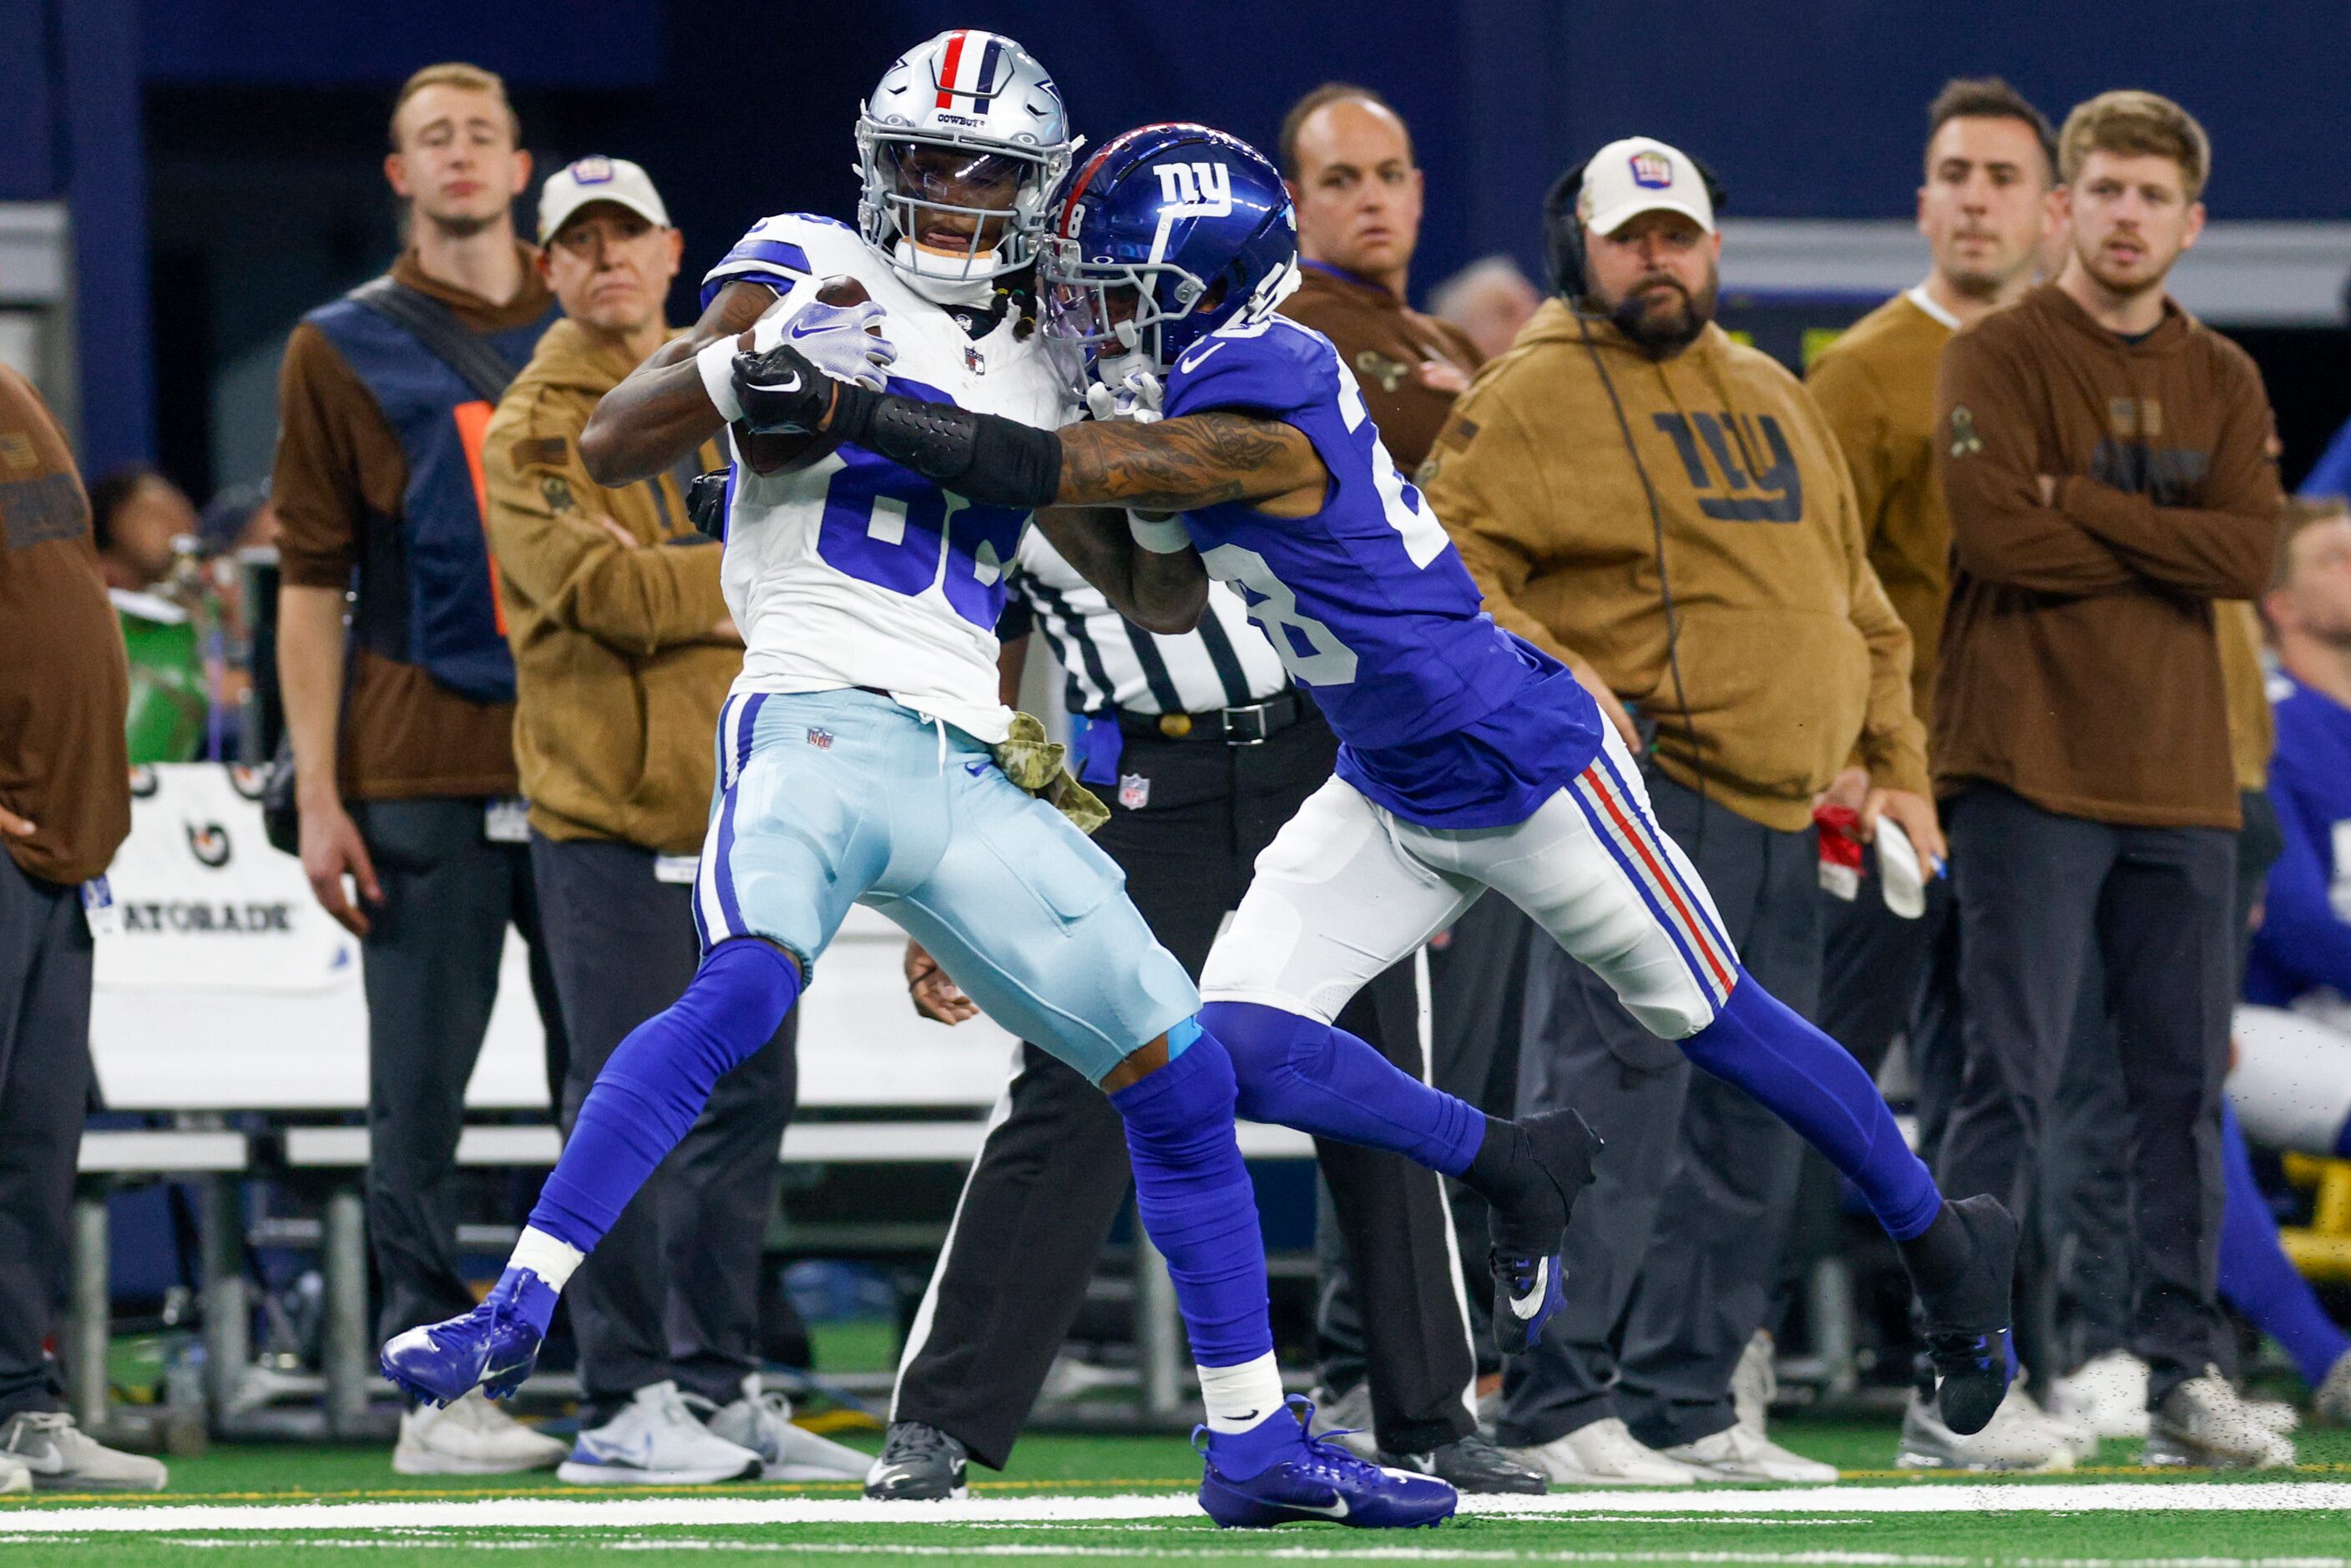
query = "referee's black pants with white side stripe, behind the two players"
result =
(891, 710, 1476, 1469)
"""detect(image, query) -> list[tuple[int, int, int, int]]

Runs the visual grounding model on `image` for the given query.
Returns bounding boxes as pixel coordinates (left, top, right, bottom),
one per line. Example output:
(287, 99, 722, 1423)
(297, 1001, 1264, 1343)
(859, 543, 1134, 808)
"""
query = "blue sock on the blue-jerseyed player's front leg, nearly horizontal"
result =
(1199, 1001, 1486, 1176)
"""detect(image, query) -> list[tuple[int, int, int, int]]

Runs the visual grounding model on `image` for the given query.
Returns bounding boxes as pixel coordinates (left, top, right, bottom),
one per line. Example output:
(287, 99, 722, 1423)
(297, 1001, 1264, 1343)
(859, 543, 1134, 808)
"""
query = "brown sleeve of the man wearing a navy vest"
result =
(270, 322, 374, 588)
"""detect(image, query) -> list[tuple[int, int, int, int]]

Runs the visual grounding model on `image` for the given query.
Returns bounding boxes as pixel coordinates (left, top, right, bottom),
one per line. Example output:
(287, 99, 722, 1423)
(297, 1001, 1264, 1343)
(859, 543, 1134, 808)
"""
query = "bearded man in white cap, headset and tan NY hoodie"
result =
(1420, 136, 1942, 1485)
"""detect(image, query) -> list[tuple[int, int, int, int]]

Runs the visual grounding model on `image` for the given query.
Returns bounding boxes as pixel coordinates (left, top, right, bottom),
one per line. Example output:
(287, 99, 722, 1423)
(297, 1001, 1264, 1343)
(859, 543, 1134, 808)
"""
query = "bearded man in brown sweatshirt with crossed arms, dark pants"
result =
(1935, 92, 2283, 1464)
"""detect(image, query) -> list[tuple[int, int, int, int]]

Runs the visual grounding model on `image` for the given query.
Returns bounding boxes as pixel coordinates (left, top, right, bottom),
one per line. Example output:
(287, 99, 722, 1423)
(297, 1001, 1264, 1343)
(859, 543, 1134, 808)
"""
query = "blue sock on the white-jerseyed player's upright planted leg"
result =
(1110, 1034, 1274, 1366)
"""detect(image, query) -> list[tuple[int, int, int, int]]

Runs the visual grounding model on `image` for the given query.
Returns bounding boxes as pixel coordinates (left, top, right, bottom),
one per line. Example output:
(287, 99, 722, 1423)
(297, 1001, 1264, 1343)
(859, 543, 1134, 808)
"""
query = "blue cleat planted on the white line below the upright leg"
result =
(1192, 1394, 1460, 1530)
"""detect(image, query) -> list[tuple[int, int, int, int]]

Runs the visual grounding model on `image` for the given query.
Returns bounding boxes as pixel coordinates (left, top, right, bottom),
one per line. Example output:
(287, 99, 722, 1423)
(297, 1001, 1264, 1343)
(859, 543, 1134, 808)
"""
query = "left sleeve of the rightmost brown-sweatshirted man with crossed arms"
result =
(1935, 331, 2141, 594)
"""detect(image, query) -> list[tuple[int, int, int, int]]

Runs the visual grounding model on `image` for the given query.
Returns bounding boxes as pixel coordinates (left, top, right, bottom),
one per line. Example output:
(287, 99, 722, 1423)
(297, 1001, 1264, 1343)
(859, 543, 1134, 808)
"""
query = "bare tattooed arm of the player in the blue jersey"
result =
(1054, 409, 1331, 517)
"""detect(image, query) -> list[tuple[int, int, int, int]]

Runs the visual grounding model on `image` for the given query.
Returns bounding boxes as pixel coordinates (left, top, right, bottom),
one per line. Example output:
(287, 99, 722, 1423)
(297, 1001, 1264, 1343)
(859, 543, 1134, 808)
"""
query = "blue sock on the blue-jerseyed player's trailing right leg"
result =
(1681, 969, 1942, 1242)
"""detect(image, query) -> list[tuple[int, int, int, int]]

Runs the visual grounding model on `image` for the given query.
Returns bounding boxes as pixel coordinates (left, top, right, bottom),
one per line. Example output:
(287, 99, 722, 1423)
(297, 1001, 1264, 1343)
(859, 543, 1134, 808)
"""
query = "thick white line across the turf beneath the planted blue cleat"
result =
(0, 1481, 2351, 1532)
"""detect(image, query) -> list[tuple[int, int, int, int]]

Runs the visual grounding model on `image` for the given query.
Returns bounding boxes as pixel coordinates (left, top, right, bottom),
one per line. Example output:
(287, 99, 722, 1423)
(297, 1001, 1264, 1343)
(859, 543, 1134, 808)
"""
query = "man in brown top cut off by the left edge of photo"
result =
(0, 364, 164, 1493)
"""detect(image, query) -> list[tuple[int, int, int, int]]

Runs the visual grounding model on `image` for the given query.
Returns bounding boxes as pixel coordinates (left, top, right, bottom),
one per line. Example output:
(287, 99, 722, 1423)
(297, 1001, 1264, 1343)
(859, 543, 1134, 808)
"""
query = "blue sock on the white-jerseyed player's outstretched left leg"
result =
(531, 938, 799, 1253)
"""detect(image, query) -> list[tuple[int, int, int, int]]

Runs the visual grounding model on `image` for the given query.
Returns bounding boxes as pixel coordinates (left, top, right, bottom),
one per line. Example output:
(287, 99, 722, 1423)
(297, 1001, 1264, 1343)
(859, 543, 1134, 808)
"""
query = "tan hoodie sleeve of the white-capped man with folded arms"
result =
(482, 416, 726, 658)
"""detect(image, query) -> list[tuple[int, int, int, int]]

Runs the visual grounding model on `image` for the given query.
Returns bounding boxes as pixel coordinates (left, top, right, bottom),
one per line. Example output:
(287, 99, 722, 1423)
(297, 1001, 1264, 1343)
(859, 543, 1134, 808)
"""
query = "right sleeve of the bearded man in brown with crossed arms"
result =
(2057, 355, 2285, 599)
